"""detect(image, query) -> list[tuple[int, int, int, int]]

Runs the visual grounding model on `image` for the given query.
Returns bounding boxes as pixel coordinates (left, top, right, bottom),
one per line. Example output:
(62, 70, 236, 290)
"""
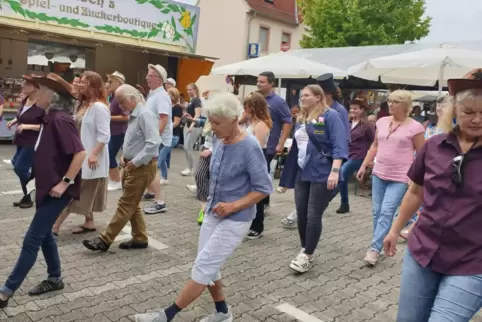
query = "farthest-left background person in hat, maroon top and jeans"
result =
(7, 75, 45, 208)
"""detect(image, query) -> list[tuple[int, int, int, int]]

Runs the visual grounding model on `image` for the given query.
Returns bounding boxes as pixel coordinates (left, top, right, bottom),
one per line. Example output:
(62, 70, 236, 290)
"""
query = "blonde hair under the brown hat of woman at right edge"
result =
(437, 89, 482, 133)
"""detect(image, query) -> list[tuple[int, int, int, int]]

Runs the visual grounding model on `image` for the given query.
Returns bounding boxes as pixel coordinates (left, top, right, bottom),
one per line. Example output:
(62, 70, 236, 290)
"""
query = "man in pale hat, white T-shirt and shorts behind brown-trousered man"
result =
(144, 64, 172, 215)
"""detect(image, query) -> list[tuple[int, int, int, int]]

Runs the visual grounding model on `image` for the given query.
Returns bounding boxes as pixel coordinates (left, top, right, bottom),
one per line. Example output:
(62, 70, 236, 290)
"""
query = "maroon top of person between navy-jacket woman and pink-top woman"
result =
(348, 122, 375, 160)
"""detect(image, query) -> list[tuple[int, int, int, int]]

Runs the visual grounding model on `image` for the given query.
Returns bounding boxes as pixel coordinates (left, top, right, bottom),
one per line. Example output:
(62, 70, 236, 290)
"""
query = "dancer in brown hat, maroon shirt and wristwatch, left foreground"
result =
(0, 73, 86, 308)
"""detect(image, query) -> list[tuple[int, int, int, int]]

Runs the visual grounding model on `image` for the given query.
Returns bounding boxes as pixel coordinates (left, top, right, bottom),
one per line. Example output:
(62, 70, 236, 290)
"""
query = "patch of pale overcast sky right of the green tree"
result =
(422, 0, 482, 42)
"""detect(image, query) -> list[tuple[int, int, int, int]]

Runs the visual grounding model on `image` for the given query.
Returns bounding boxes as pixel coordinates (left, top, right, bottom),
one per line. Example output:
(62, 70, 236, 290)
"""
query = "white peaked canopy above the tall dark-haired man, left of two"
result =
(211, 52, 346, 78)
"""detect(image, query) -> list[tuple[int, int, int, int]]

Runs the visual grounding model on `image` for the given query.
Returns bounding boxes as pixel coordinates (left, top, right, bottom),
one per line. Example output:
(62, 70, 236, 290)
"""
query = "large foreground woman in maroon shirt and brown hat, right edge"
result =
(384, 70, 482, 322)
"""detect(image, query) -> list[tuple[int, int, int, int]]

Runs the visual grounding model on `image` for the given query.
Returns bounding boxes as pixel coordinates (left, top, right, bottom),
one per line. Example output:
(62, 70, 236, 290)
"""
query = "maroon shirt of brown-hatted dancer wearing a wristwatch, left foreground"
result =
(32, 110, 84, 206)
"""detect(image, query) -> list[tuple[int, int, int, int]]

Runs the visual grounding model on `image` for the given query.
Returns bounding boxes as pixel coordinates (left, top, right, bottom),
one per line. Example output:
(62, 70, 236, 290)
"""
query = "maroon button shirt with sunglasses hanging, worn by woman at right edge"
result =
(408, 134, 482, 275)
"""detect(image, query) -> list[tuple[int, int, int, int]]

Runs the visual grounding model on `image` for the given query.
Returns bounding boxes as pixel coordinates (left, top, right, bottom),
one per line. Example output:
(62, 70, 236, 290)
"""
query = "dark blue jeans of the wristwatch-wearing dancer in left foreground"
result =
(0, 196, 71, 296)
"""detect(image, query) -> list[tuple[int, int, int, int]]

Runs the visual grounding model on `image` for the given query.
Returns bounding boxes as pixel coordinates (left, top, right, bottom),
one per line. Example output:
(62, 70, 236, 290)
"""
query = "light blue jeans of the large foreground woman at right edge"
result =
(397, 249, 482, 322)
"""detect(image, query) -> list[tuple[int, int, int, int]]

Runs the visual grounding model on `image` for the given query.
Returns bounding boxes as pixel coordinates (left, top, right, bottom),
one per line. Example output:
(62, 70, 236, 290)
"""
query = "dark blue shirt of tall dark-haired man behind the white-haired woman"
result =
(265, 93, 291, 155)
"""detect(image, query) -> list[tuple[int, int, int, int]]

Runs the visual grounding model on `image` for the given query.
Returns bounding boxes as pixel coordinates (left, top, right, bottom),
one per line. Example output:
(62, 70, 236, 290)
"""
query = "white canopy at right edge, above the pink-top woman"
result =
(348, 45, 482, 86)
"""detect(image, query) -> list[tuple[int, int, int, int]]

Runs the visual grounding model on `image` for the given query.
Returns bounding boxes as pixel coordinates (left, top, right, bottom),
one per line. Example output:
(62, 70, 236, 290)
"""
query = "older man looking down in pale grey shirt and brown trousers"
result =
(83, 85, 161, 252)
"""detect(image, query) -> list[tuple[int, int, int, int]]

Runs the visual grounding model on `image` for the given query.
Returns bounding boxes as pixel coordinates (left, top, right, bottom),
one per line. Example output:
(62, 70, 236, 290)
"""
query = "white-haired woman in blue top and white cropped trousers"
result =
(136, 93, 273, 322)
